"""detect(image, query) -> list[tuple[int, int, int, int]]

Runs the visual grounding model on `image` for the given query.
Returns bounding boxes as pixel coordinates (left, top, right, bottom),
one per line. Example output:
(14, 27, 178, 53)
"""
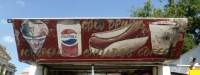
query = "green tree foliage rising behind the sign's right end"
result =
(129, 0, 200, 53)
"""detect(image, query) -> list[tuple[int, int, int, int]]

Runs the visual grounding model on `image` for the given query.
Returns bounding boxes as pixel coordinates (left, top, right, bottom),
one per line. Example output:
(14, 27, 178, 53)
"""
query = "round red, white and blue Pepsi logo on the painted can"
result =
(60, 29, 77, 46)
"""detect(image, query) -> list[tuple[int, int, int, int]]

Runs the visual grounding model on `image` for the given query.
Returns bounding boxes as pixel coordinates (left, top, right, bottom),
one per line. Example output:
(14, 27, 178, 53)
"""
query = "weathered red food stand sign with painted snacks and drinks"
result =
(12, 18, 188, 63)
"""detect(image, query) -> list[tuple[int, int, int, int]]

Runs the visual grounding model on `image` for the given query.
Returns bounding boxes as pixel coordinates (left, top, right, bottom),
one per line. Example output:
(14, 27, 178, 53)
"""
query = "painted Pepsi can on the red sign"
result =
(57, 20, 82, 57)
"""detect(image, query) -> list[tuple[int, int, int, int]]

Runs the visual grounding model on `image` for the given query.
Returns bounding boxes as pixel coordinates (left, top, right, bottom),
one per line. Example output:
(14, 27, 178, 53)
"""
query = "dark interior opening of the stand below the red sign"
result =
(43, 64, 153, 75)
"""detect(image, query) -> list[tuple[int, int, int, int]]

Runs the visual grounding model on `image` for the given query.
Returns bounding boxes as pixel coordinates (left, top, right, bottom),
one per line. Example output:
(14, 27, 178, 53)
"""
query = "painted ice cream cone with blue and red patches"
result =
(20, 20, 49, 52)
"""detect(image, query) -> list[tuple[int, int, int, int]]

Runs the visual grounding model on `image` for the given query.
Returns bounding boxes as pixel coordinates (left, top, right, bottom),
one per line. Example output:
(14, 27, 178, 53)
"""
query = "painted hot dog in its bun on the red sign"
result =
(89, 21, 148, 56)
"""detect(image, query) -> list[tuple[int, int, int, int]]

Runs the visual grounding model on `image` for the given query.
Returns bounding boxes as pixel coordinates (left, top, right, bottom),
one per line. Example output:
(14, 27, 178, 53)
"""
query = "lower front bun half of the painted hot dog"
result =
(90, 37, 148, 57)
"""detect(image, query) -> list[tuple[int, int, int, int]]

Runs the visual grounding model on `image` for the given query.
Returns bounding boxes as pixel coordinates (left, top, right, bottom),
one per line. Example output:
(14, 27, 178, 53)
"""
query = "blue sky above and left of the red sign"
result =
(0, 0, 167, 75)
